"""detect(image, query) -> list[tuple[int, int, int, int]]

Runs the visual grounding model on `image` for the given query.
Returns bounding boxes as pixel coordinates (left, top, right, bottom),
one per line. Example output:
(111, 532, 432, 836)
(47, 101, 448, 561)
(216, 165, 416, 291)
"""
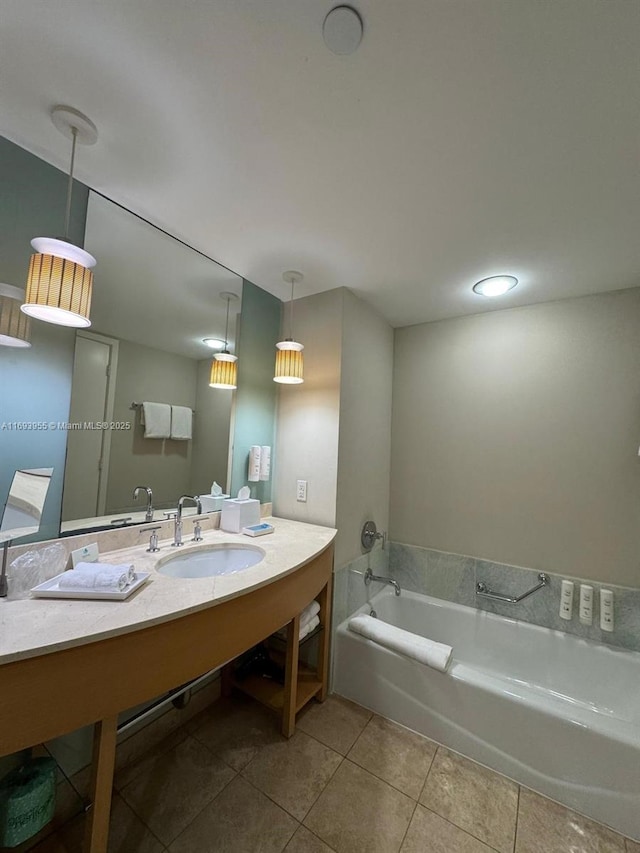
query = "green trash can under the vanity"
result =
(0, 758, 56, 847)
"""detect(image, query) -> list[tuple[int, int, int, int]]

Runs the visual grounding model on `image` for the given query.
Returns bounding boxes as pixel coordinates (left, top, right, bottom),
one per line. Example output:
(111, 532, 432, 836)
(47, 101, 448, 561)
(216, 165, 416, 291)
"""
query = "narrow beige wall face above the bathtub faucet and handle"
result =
(335, 290, 393, 567)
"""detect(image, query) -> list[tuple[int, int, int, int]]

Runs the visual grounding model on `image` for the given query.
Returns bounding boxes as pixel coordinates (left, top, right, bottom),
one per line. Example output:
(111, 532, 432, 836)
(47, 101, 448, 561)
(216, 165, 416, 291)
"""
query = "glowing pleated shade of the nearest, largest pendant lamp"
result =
(22, 237, 96, 328)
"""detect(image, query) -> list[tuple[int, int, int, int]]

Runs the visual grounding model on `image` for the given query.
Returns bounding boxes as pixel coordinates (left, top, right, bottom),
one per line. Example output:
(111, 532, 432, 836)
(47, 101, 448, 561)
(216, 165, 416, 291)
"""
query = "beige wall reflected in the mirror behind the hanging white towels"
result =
(107, 341, 197, 513)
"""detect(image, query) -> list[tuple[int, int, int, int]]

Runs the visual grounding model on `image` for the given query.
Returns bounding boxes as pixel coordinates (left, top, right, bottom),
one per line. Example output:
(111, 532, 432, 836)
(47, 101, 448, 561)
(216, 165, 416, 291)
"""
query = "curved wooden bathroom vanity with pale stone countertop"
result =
(0, 519, 336, 853)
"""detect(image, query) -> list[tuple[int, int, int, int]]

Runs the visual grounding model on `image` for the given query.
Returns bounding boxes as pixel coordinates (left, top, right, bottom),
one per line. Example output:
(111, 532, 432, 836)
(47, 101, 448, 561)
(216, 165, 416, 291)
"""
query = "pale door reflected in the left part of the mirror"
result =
(62, 332, 118, 521)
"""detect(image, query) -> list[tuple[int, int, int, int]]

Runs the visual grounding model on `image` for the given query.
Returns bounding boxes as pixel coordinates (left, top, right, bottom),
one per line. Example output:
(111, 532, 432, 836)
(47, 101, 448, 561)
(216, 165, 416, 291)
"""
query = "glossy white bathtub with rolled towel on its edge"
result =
(333, 588, 640, 839)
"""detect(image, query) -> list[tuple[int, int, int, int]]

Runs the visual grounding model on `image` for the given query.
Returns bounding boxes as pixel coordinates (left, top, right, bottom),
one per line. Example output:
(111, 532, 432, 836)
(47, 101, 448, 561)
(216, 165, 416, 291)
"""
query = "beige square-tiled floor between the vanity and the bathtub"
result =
(22, 696, 640, 853)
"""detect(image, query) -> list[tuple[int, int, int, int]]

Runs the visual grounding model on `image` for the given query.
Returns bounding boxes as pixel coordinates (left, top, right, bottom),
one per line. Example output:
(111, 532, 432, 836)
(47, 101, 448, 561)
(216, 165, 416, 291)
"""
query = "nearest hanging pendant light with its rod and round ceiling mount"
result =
(22, 107, 98, 328)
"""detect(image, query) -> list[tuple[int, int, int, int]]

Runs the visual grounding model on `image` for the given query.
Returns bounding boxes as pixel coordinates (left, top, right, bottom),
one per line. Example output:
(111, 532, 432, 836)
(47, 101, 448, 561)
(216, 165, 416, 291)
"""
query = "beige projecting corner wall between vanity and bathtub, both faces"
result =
(273, 287, 393, 567)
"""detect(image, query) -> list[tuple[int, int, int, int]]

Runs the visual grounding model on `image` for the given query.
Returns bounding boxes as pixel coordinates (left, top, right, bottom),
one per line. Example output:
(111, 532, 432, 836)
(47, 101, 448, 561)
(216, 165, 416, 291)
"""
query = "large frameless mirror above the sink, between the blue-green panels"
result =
(62, 192, 242, 532)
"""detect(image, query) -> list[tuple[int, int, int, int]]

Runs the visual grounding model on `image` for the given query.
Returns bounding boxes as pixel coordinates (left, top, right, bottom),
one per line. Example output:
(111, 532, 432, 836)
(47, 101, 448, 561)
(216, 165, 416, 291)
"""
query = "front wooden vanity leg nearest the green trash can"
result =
(83, 716, 118, 853)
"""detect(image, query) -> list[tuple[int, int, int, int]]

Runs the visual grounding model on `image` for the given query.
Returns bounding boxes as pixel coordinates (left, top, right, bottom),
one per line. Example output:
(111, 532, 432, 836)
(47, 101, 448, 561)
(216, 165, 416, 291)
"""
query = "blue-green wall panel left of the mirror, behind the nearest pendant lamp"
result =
(0, 137, 89, 542)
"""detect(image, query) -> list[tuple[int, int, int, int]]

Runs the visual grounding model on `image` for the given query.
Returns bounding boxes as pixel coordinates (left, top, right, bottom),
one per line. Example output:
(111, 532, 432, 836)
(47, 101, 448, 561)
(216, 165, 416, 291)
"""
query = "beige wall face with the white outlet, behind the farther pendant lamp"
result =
(273, 289, 343, 527)
